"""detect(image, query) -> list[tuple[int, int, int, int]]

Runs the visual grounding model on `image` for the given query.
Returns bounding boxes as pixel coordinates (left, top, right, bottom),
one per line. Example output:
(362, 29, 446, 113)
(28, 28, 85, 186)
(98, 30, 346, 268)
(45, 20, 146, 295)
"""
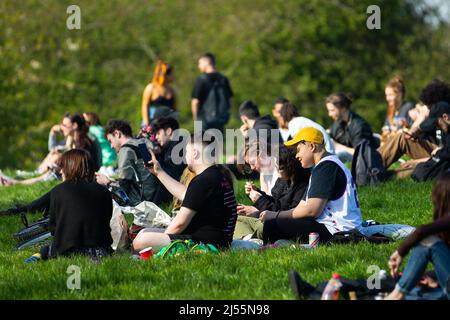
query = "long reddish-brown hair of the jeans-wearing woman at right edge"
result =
(431, 171, 450, 244)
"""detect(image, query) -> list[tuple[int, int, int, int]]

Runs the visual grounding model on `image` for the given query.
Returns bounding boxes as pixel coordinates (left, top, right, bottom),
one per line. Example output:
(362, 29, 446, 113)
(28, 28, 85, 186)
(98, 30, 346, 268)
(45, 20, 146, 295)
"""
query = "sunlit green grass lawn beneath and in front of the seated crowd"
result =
(0, 179, 432, 299)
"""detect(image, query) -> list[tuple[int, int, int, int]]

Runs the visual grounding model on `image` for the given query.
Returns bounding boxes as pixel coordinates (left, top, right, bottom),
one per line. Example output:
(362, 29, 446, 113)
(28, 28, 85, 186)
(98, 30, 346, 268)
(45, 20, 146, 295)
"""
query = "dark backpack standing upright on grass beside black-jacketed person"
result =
(352, 139, 387, 187)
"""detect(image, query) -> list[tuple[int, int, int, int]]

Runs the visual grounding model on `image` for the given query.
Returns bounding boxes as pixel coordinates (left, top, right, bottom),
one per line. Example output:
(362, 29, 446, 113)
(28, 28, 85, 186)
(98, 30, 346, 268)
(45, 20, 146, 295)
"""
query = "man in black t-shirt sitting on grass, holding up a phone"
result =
(133, 134, 237, 253)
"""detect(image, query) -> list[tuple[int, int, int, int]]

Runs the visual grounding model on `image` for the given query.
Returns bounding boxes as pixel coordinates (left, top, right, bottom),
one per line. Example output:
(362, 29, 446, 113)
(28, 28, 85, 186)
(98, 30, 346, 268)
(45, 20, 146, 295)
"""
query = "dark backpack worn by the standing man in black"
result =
(200, 75, 230, 127)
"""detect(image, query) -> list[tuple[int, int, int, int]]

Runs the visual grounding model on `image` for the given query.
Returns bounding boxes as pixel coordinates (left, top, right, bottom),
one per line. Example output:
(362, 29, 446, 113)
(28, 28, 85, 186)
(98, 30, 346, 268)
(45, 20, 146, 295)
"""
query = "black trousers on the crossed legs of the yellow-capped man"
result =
(263, 218, 332, 243)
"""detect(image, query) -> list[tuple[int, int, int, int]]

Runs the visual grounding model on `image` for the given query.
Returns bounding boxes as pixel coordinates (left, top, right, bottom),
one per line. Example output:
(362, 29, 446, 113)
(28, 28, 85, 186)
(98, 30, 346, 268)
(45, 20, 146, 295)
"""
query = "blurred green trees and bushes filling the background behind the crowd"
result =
(0, 0, 450, 169)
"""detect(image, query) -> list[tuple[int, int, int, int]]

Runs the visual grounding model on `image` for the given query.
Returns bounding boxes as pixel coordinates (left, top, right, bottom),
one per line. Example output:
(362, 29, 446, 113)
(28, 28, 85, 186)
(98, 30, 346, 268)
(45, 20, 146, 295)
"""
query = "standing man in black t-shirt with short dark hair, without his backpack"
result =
(191, 53, 233, 131)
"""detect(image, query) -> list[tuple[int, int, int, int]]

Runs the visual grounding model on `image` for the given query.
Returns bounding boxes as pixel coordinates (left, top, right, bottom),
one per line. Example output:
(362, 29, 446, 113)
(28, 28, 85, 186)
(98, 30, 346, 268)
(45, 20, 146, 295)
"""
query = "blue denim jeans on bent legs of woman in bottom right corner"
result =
(396, 237, 450, 298)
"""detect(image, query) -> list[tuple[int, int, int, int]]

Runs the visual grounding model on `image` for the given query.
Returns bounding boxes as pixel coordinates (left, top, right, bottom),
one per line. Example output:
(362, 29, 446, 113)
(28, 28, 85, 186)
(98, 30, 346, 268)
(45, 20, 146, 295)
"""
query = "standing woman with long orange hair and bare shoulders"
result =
(141, 60, 176, 127)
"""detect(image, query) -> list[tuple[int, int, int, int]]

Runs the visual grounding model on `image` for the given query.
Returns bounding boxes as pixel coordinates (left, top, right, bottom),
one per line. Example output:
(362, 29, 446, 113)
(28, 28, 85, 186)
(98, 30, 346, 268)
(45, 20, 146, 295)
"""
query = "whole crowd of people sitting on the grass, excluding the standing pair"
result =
(0, 55, 450, 298)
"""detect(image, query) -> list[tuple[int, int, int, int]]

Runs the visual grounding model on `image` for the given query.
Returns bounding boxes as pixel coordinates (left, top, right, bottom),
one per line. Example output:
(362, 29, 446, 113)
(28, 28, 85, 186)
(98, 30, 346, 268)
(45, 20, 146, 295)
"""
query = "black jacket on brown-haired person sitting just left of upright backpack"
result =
(330, 111, 380, 148)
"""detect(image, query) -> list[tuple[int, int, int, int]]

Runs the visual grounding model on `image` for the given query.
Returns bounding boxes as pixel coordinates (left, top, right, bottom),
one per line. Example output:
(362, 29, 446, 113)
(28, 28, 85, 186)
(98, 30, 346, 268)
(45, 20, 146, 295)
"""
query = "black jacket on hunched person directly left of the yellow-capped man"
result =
(255, 179, 308, 211)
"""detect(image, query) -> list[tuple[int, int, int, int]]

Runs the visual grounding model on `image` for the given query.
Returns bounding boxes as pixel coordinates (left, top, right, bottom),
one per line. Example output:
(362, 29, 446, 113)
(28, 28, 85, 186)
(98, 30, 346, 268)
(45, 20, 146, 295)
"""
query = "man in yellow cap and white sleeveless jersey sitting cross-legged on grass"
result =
(259, 128, 361, 243)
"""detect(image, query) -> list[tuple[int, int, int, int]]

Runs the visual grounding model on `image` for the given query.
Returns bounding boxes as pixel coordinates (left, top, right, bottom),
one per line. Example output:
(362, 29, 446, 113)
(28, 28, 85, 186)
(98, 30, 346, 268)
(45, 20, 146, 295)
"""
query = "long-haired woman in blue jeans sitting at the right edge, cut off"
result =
(386, 171, 450, 300)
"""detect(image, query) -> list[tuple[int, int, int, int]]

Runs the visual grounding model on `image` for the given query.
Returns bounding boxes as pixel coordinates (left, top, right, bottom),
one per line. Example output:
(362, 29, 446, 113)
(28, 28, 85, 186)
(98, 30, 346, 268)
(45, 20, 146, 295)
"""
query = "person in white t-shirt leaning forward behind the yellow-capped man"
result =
(280, 102, 334, 153)
